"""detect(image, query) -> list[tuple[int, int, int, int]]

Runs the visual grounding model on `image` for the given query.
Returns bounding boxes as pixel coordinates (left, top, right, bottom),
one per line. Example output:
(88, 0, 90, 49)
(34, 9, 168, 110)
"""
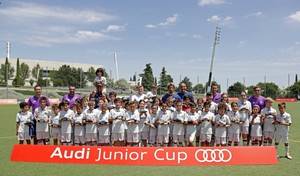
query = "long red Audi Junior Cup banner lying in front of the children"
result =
(11, 144, 277, 166)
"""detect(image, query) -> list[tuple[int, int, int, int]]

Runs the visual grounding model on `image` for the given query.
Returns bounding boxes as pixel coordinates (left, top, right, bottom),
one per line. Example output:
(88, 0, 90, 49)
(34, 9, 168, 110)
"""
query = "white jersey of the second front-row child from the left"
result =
(34, 107, 51, 132)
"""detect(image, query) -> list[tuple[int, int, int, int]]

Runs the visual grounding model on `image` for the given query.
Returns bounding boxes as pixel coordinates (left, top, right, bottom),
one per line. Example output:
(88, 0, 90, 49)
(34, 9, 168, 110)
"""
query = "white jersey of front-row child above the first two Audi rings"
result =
(200, 111, 215, 134)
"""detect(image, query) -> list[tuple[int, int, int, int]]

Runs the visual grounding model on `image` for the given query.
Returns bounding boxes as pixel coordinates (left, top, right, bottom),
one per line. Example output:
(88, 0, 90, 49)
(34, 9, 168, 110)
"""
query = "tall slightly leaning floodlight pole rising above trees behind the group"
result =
(205, 26, 221, 92)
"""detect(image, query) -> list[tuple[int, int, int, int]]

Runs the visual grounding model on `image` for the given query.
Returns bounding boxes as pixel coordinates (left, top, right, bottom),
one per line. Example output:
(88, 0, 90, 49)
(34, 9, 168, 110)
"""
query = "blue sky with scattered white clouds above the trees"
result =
(0, 0, 300, 91)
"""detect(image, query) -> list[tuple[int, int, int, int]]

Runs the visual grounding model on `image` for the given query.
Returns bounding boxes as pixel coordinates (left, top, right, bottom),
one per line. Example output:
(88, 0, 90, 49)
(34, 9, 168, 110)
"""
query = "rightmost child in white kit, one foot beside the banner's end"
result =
(275, 103, 292, 159)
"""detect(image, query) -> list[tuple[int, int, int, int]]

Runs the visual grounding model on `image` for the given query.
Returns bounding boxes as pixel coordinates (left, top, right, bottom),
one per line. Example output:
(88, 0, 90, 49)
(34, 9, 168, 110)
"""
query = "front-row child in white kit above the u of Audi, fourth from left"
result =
(59, 101, 75, 145)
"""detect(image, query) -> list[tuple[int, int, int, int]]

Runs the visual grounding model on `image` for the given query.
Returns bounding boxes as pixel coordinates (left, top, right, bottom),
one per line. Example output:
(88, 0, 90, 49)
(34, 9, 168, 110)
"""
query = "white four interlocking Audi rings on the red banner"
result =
(195, 149, 232, 163)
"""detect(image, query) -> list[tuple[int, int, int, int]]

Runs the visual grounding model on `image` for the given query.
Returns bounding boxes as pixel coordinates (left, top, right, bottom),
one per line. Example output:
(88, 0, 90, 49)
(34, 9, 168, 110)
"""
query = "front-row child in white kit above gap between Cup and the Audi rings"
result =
(185, 103, 200, 147)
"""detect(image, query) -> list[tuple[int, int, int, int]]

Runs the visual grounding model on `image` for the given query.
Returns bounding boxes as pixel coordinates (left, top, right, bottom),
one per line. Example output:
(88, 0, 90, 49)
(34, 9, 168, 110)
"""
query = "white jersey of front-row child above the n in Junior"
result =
(110, 108, 127, 133)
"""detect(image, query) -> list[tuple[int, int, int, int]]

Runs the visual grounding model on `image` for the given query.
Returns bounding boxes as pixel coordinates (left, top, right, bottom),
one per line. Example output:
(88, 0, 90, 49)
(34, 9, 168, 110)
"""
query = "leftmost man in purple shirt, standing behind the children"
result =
(27, 85, 50, 144)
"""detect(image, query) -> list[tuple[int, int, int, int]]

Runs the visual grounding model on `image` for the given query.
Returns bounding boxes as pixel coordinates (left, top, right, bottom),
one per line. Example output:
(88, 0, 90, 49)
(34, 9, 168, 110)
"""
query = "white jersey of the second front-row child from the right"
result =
(261, 107, 277, 132)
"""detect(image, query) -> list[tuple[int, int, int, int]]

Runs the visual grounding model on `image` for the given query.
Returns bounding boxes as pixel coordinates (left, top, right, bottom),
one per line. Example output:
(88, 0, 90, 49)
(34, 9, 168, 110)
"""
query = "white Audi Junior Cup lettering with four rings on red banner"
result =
(50, 147, 232, 164)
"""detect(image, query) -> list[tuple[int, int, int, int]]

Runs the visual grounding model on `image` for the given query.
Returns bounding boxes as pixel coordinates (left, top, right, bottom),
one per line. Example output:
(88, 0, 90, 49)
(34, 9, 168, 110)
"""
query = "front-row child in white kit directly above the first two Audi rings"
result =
(199, 102, 215, 147)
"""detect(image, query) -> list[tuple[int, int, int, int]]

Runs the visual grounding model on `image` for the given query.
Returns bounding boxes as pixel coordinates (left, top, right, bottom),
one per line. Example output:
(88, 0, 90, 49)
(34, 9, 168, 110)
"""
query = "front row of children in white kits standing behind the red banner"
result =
(16, 90, 292, 159)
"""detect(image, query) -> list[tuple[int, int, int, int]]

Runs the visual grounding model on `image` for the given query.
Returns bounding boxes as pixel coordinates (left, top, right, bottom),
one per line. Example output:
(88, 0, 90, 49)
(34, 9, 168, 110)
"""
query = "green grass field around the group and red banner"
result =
(0, 103, 300, 176)
